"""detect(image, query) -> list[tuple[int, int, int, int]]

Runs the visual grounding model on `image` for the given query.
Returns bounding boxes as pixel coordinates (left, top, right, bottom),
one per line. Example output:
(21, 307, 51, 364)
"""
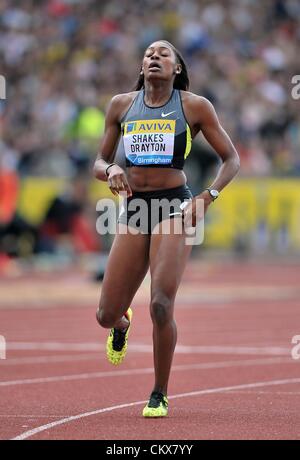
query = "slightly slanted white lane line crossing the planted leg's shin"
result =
(0, 358, 295, 387)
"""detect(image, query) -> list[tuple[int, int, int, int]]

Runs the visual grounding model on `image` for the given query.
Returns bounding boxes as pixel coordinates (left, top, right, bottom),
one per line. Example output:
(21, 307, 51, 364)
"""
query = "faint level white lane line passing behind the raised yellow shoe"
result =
(7, 342, 291, 356)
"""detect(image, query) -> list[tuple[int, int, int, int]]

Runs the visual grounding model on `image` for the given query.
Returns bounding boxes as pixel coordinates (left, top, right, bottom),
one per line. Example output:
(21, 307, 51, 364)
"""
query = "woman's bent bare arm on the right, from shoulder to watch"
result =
(194, 96, 240, 192)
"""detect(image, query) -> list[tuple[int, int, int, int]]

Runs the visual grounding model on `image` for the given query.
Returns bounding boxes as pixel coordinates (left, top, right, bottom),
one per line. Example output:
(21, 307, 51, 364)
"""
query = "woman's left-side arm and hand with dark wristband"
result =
(93, 94, 132, 195)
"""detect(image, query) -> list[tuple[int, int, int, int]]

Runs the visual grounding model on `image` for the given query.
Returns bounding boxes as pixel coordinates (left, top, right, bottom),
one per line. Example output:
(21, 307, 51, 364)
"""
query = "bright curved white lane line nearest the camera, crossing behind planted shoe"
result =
(12, 378, 300, 441)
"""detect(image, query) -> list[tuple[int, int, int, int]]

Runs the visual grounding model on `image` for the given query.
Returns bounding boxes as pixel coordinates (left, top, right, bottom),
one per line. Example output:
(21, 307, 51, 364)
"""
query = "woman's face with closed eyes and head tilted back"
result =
(142, 42, 181, 80)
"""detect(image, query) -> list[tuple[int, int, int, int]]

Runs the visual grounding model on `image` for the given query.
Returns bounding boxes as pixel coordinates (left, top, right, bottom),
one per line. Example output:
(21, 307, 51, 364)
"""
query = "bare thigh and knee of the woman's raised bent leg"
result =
(97, 224, 150, 329)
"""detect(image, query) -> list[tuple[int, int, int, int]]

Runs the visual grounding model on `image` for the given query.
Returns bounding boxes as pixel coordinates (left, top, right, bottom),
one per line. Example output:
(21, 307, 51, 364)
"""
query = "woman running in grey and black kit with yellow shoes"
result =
(94, 40, 239, 417)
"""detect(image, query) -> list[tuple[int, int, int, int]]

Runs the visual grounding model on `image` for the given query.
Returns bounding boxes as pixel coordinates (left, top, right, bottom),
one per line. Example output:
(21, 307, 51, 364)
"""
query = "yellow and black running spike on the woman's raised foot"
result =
(106, 308, 132, 366)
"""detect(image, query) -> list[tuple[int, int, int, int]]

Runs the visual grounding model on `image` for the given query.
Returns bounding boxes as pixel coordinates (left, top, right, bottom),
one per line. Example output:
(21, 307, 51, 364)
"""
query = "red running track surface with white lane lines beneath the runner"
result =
(0, 262, 300, 440)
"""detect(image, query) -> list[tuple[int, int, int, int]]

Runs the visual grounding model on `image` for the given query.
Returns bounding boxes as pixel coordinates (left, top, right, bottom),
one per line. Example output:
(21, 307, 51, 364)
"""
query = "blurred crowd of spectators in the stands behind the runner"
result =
(0, 0, 300, 177)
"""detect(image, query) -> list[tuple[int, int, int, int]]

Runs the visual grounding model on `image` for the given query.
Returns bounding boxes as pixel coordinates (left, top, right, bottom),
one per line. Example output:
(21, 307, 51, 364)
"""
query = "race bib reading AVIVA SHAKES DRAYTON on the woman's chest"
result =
(123, 119, 176, 166)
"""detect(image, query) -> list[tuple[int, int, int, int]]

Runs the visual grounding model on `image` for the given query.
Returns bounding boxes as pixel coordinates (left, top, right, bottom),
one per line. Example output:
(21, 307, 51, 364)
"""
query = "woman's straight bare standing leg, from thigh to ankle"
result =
(150, 218, 192, 394)
